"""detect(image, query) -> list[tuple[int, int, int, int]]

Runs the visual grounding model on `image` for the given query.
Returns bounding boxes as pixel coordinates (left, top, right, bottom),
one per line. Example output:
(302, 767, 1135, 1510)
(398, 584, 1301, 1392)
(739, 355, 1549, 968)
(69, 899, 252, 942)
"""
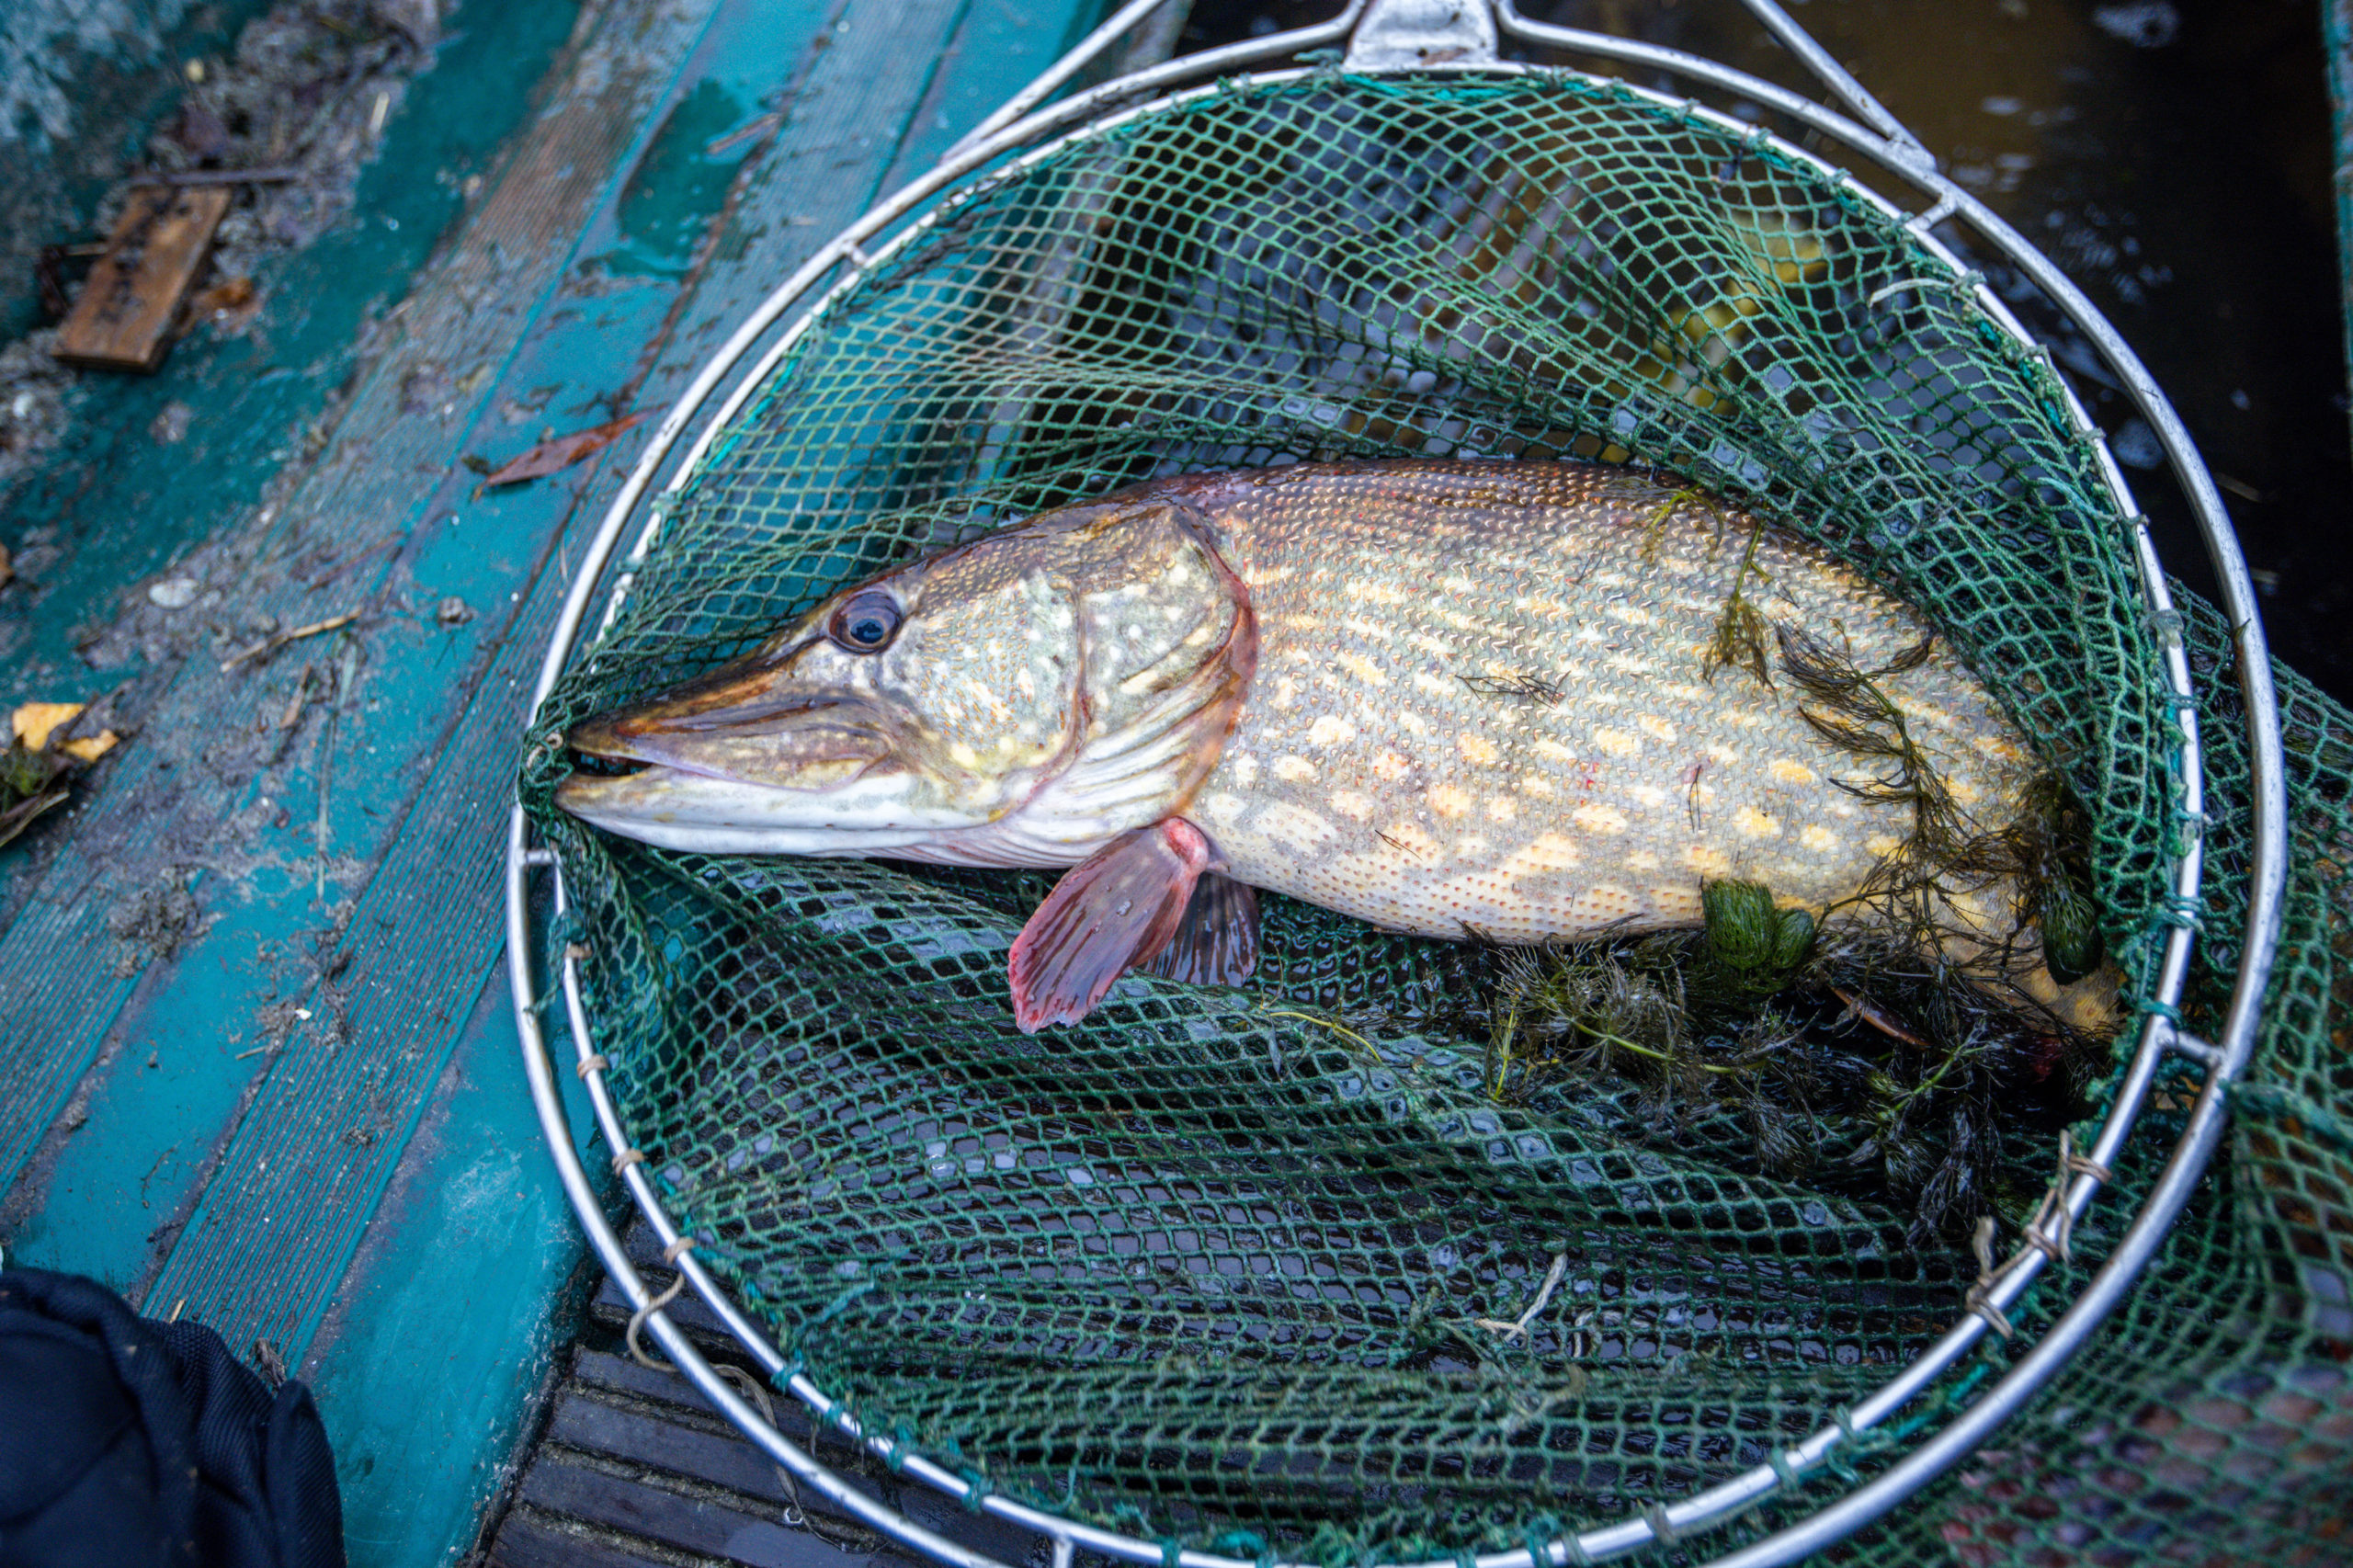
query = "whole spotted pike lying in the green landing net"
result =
(558, 460, 2099, 1031)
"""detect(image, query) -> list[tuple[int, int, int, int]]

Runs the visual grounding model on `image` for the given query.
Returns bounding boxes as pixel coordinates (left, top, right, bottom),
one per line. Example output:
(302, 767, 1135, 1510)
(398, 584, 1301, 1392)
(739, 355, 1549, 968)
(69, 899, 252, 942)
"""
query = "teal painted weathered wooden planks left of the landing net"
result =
(0, 0, 1101, 1565)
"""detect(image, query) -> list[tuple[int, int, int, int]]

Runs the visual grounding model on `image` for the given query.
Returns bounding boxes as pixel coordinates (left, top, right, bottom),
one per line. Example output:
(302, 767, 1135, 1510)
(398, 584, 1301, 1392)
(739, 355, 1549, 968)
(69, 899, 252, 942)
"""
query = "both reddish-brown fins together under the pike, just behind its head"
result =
(1005, 817, 1259, 1034)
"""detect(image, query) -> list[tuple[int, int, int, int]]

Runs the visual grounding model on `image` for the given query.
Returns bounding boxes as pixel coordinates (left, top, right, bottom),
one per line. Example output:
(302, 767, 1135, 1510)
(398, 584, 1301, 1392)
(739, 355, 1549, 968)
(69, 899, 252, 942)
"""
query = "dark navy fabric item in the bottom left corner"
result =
(0, 1269, 344, 1568)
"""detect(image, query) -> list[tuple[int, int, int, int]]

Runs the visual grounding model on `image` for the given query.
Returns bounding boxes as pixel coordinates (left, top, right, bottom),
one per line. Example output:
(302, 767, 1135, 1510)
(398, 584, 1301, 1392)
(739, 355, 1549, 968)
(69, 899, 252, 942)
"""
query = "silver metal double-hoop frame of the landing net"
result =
(506, 0, 2287, 1568)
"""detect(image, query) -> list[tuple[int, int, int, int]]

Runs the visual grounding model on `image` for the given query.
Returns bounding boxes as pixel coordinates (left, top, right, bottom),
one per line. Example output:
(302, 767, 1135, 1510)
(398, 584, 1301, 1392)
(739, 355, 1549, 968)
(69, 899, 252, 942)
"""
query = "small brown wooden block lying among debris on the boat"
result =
(56, 188, 231, 369)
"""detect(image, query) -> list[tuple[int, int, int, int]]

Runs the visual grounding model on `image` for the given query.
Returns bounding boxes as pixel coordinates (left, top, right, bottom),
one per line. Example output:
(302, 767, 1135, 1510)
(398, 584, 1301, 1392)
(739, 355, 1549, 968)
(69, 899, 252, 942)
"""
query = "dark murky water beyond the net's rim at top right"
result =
(1184, 0, 2353, 699)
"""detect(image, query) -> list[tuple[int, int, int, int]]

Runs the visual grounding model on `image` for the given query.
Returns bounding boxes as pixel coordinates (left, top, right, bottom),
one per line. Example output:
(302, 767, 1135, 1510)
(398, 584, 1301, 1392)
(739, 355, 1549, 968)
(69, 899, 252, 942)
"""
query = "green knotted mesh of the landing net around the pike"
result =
(522, 71, 2353, 1563)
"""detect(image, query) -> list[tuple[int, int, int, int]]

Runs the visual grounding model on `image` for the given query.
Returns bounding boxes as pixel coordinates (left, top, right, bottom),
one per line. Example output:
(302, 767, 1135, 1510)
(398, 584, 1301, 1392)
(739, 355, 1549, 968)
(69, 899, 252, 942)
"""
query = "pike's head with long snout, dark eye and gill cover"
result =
(555, 502, 1256, 867)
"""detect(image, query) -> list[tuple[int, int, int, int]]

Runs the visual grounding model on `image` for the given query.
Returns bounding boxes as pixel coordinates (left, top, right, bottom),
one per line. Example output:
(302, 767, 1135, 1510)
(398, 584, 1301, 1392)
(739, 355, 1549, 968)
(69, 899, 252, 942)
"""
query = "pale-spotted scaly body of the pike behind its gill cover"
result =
(1186, 464, 2030, 942)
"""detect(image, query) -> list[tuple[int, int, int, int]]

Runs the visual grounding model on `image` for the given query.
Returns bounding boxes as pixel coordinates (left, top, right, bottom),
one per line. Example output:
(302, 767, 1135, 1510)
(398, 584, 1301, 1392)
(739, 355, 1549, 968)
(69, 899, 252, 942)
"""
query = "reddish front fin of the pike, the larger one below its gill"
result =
(1005, 817, 1213, 1034)
